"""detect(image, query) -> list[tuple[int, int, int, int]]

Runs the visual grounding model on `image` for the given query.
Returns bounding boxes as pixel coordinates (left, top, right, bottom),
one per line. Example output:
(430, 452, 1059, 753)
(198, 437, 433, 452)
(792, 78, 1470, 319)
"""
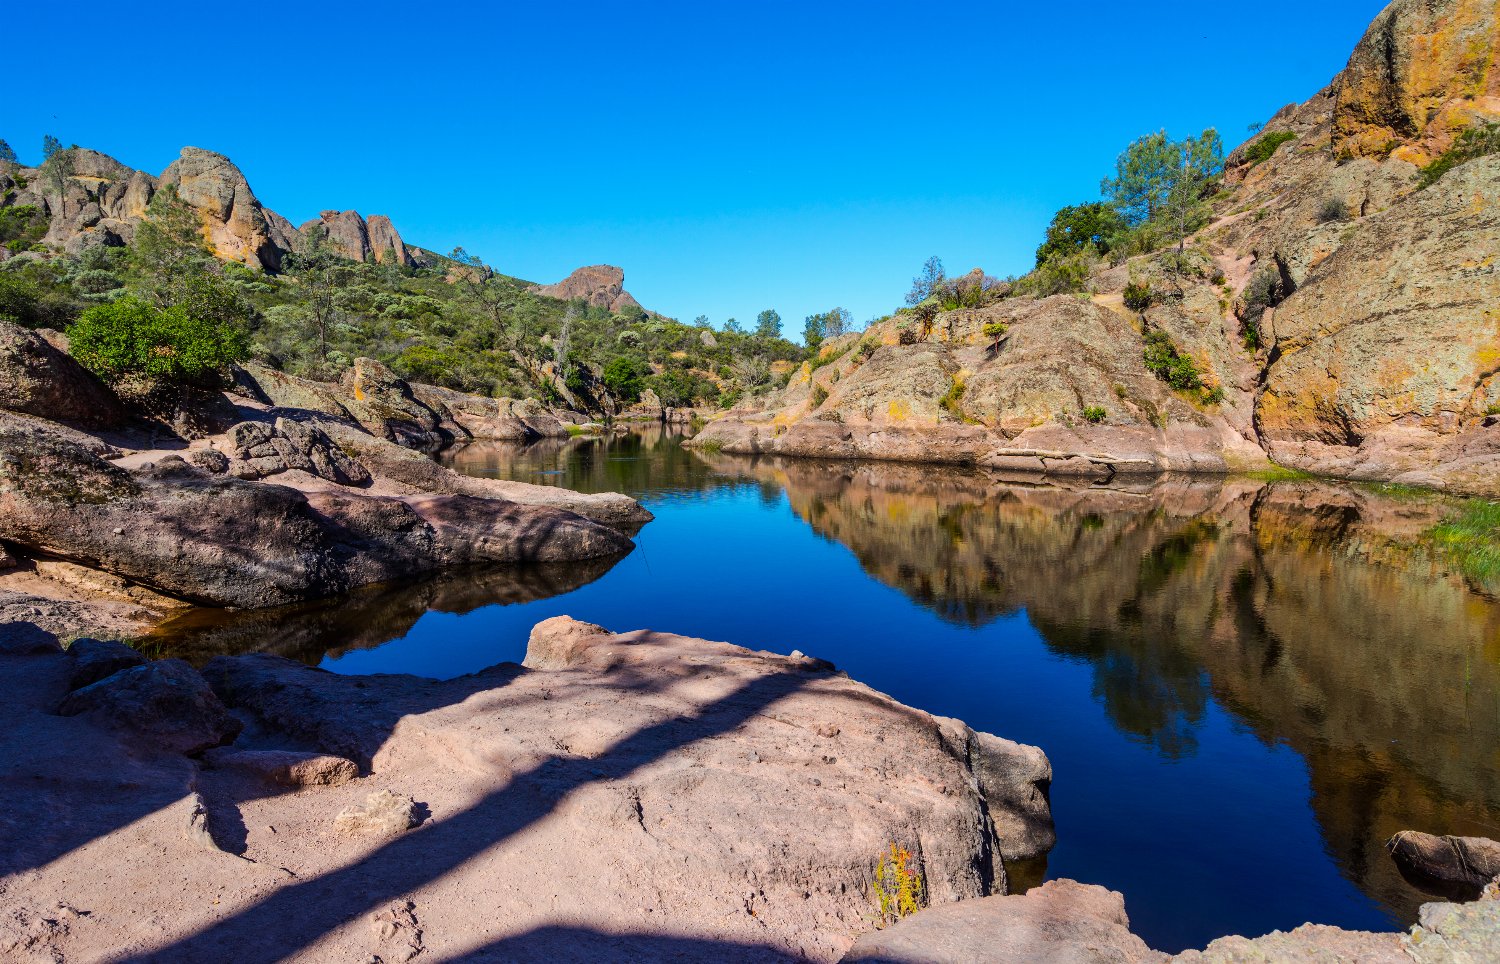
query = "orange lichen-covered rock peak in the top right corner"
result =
(1334, 0, 1500, 165)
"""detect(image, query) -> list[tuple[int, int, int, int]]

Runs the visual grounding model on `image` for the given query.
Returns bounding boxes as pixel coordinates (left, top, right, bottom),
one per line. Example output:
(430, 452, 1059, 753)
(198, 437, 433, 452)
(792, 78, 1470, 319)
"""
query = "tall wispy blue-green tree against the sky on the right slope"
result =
(1100, 127, 1224, 247)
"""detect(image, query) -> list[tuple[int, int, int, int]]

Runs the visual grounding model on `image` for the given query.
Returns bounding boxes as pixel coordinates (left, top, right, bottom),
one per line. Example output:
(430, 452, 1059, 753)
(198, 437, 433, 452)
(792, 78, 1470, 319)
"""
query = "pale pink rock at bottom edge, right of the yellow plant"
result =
(843, 880, 1167, 964)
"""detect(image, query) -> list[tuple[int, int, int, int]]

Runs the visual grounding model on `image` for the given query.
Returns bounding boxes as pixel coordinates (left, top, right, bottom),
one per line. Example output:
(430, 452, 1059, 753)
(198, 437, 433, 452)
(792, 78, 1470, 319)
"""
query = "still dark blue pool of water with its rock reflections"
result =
(152, 430, 1500, 951)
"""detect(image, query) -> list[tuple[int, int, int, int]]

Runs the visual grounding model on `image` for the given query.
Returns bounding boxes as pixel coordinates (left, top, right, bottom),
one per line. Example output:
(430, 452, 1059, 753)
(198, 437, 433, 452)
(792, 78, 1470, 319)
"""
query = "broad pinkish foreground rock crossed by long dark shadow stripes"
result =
(0, 618, 1050, 961)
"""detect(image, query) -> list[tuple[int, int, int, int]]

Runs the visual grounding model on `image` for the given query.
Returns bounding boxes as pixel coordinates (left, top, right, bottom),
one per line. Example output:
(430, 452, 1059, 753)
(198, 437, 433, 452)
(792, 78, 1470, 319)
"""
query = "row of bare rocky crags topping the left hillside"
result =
(0, 147, 416, 271)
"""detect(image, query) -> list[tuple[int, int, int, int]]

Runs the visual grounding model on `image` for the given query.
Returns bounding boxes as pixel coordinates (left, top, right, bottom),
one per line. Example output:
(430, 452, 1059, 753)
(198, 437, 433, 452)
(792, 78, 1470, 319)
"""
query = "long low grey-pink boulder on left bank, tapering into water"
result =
(0, 420, 630, 607)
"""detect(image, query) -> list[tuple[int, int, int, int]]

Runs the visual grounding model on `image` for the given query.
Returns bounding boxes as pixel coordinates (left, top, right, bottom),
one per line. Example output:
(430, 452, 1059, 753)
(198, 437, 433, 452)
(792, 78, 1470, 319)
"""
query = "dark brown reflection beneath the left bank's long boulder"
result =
(143, 556, 620, 666)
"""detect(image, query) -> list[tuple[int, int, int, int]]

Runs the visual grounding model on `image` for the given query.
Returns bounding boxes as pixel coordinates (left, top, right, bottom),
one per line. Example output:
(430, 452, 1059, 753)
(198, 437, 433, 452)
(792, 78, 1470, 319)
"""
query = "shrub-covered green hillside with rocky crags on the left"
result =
(0, 144, 804, 417)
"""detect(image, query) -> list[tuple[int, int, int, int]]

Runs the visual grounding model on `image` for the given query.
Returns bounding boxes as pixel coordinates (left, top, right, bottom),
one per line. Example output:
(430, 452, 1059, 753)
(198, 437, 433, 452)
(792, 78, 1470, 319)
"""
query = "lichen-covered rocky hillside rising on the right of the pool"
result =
(699, 0, 1500, 495)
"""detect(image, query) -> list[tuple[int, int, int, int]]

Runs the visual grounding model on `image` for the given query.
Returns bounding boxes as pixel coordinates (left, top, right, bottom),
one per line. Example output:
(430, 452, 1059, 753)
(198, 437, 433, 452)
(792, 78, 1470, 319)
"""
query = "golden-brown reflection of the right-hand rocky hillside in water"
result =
(714, 457, 1500, 919)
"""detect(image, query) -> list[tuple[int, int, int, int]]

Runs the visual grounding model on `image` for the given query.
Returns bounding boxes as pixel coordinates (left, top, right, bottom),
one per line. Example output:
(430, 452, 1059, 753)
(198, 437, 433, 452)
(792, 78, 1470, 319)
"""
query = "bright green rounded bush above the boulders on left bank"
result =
(68, 297, 249, 385)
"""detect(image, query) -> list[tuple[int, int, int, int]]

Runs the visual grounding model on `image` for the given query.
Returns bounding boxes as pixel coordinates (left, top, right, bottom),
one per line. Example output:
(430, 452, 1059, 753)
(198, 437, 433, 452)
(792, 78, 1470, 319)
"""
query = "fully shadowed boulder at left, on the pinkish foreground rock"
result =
(59, 660, 242, 754)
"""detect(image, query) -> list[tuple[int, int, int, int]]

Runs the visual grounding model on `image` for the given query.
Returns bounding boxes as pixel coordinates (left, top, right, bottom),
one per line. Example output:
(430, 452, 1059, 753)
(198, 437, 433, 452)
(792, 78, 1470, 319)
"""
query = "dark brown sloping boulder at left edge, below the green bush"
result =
(0, 319, 125, 427)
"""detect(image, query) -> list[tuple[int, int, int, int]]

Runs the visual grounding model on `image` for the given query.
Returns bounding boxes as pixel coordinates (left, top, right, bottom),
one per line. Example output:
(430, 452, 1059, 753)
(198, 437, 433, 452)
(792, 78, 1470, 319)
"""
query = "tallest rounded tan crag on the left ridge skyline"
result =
(159, 147, 282, 270)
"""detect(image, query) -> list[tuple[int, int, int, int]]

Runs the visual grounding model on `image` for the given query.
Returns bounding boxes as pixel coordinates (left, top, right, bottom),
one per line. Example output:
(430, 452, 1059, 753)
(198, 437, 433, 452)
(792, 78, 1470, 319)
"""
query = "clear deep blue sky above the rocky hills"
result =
(0, 0, 1383, 331)
